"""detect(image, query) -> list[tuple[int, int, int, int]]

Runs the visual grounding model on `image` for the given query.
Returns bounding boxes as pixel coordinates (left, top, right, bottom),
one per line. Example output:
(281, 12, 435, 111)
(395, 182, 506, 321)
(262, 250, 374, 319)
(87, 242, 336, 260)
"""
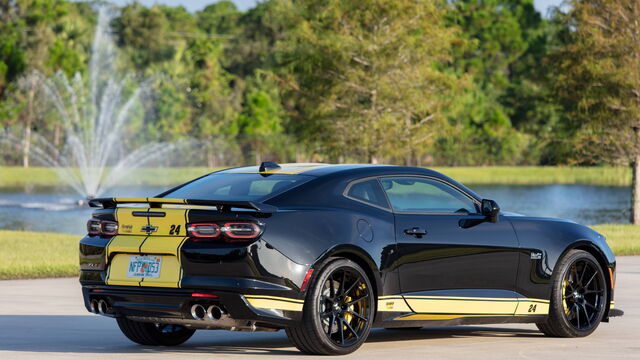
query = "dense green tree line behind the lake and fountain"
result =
(0, 0, 640, 177)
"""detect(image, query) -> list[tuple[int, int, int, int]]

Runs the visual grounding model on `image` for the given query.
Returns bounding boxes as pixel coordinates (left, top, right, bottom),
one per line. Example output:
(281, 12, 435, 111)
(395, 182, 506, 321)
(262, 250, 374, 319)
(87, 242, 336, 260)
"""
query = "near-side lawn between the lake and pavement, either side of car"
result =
(0, 225, 640, 280)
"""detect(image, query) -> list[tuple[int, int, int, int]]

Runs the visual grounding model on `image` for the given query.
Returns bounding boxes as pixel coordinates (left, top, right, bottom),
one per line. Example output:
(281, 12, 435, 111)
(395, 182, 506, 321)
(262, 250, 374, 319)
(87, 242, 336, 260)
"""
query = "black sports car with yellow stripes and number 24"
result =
(80, 162, 621, 354)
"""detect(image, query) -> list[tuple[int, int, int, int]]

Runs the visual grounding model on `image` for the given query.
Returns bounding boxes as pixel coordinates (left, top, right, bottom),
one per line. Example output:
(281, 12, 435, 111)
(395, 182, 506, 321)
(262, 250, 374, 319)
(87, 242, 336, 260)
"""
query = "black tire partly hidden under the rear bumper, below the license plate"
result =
(116, 317, 196, 346)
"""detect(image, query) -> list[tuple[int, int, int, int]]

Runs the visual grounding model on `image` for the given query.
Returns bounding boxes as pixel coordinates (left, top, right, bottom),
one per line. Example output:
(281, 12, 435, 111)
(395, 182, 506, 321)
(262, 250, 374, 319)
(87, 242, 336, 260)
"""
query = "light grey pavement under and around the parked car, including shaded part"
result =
(0, 256, 640, 360)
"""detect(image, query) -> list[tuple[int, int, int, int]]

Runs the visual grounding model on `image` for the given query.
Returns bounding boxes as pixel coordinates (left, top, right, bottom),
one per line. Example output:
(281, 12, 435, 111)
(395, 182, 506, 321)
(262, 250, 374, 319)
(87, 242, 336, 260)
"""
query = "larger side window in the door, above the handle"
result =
(380, 176, 477, 213)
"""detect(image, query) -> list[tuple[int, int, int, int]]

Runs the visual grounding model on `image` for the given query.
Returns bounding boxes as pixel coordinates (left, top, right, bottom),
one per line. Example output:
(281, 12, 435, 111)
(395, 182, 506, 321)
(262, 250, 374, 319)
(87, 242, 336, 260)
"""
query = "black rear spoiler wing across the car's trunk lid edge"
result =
(89, 198, 277, 213)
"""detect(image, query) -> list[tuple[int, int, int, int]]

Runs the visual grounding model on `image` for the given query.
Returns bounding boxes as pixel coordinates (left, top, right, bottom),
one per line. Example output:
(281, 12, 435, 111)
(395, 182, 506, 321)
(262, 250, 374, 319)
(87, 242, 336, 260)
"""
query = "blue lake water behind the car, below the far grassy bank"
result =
(0, 185, 631, 234)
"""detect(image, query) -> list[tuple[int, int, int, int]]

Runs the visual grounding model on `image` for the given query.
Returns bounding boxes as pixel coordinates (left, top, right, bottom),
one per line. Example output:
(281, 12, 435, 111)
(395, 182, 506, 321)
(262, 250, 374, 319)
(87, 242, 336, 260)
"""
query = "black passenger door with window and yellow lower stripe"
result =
(380, 176, 518, 320)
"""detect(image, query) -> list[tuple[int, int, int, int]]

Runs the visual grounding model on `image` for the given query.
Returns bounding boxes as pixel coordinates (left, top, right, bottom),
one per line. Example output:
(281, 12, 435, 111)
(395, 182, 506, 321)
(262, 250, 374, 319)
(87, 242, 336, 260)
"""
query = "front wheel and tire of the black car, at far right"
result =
(536, 250, 608, 337)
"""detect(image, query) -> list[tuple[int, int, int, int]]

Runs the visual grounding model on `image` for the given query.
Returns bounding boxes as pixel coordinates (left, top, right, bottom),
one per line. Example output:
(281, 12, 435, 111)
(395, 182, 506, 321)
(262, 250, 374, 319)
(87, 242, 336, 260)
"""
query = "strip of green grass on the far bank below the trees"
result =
(0, 166, 631, 188)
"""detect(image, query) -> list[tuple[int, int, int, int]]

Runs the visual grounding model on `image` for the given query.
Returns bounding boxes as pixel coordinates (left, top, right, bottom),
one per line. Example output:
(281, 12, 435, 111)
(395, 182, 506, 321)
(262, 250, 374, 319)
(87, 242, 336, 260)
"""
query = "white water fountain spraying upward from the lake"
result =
(0, 5, 184, 198)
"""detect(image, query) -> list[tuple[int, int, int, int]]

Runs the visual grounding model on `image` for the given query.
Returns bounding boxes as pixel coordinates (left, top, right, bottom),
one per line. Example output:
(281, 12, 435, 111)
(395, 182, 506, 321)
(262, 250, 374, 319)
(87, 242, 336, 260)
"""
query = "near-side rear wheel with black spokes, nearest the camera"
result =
(286, 259, 376, 355)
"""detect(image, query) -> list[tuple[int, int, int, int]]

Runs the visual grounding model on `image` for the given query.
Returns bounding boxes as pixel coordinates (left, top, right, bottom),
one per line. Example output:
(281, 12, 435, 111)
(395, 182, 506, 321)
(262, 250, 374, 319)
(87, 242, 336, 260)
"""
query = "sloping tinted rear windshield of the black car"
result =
(163, 173, 313, 201)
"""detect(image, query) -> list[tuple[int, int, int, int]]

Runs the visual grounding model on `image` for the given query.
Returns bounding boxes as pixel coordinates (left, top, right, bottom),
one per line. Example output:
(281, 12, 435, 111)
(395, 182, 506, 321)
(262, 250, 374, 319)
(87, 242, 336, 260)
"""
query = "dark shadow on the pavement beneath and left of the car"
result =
(0, 315, 541, 356)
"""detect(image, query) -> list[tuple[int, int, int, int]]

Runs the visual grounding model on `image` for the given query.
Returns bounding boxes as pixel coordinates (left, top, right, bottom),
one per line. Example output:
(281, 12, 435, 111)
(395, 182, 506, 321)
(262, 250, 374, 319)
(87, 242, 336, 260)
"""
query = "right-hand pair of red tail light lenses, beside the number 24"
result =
(187, 221, 263, 242)
